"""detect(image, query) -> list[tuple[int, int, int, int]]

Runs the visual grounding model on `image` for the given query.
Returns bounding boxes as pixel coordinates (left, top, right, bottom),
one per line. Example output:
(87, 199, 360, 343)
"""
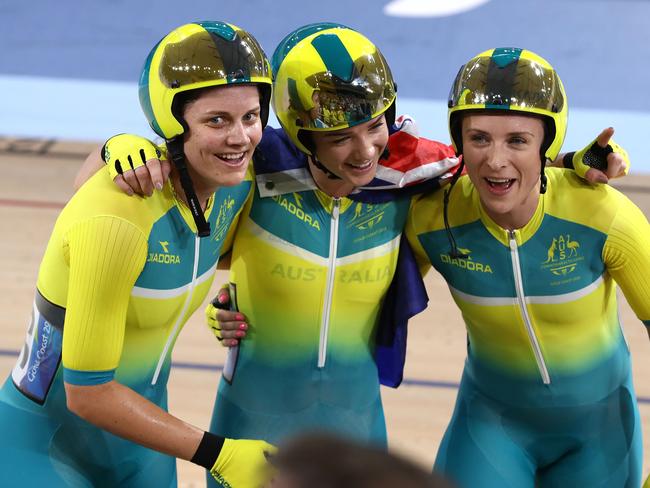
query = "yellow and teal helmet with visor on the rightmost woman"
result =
(448, 48, 568, 161)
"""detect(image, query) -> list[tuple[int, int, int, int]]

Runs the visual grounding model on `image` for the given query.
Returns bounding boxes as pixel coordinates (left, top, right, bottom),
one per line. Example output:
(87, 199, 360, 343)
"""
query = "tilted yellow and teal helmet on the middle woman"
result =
(272, 23, 396, 154)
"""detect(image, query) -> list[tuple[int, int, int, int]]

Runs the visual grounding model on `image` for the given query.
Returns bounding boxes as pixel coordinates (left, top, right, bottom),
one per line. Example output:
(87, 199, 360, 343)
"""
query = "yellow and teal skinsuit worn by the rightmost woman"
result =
(407, 168, 650, 487)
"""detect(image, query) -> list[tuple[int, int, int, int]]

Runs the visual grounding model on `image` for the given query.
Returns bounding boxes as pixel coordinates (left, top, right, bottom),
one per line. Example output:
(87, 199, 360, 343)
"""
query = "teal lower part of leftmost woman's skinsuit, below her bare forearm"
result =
(0, 378, 177, 488)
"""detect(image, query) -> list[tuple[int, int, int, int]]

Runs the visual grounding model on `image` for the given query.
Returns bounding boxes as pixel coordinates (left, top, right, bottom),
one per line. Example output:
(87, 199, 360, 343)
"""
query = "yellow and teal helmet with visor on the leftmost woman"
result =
(139, 21, 272, 140)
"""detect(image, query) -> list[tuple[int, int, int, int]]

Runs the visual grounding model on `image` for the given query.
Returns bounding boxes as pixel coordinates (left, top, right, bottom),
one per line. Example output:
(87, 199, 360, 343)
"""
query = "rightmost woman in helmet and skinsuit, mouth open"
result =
(407, 48, 650, 488)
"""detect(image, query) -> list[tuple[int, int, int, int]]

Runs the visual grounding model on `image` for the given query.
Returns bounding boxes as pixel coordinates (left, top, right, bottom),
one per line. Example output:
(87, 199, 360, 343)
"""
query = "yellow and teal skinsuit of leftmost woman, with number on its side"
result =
(0, 166, 252, 486)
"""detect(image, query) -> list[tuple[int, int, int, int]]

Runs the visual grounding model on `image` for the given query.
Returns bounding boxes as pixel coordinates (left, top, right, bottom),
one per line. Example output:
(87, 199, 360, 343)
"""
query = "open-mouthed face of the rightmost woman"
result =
(462, 114, 544, 229)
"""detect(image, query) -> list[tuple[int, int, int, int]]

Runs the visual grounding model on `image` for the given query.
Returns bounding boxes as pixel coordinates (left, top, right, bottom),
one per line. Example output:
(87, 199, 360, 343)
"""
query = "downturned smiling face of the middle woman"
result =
(310, 114, 388, 191)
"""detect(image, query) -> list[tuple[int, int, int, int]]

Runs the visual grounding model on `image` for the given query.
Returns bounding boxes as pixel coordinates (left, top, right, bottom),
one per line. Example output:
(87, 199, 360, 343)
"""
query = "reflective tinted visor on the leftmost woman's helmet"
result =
(160, 31, 271, 89)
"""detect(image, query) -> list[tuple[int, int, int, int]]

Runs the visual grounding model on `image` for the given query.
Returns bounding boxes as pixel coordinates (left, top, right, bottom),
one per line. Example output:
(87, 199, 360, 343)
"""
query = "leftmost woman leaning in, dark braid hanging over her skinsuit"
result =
(0, 22, 271, 487)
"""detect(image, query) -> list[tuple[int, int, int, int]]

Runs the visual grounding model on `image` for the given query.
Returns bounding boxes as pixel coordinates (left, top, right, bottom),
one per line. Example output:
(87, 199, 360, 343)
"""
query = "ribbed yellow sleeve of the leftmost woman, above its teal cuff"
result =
(63, 216, 147, 371)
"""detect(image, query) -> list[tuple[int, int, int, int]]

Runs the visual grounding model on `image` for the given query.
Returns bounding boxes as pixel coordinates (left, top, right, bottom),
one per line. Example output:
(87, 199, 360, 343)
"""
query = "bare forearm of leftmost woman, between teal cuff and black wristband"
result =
(65, 381, 204, 460)
